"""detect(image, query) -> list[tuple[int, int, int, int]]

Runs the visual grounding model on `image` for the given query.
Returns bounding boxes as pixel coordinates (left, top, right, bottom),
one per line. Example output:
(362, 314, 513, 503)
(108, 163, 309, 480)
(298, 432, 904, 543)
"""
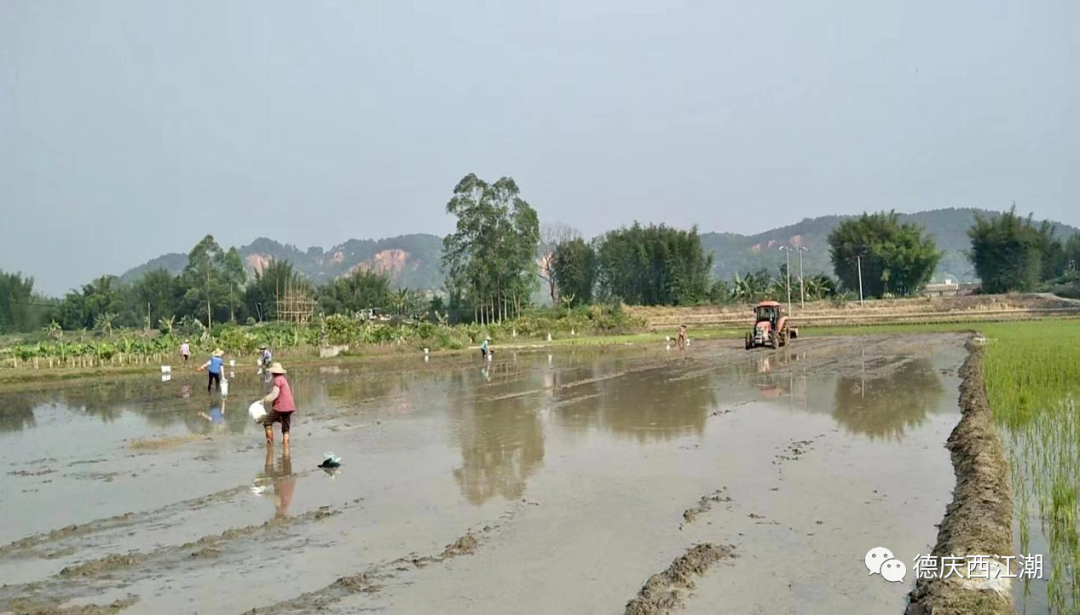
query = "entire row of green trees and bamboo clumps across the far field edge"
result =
(0, 179, 1080, 333)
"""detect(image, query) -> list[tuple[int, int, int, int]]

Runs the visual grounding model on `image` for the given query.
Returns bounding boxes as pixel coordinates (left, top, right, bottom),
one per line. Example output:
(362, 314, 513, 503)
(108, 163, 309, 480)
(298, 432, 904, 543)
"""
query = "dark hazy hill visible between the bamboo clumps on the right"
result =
(701, 209, 1080, 282)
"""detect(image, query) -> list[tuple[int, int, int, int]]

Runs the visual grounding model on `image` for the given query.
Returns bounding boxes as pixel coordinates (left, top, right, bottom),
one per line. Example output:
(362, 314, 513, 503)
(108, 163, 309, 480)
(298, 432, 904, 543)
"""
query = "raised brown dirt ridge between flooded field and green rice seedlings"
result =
(905, 339, 1014, 615)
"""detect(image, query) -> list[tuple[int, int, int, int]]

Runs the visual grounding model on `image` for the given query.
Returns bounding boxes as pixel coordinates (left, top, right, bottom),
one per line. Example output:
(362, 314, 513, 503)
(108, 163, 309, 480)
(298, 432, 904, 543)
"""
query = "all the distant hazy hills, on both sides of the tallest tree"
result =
(121, 209, 1080, 289)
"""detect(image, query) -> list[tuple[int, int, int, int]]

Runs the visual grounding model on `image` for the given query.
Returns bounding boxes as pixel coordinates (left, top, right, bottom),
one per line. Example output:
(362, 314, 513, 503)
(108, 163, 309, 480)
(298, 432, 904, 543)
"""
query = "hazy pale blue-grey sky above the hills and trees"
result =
(0, 0, 1080, 293)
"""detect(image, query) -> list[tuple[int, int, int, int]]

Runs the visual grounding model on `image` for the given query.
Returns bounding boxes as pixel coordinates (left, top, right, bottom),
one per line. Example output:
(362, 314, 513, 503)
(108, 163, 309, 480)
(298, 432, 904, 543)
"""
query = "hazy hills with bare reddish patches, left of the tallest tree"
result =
(120, 235, 443, 289)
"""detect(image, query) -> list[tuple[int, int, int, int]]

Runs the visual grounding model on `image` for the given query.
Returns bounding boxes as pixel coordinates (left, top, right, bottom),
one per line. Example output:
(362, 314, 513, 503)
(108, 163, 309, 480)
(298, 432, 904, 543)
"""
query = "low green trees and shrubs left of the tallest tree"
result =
(0, 236, 429, 334)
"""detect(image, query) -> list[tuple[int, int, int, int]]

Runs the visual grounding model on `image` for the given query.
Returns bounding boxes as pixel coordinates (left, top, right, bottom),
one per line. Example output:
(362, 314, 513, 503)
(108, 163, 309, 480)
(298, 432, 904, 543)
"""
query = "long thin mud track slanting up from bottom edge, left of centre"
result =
(244, 499, 537, 615)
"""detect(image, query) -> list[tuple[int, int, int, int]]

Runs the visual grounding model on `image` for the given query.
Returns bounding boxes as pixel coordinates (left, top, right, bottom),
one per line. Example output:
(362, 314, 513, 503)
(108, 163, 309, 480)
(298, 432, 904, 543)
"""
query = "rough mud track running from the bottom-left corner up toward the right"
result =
(0, 498, 362, 612)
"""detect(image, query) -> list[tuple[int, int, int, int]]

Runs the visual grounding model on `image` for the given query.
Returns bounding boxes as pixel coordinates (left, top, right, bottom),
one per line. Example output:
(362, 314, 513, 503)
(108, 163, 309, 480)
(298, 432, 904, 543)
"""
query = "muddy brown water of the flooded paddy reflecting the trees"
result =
(0, 336, 963, 614)
